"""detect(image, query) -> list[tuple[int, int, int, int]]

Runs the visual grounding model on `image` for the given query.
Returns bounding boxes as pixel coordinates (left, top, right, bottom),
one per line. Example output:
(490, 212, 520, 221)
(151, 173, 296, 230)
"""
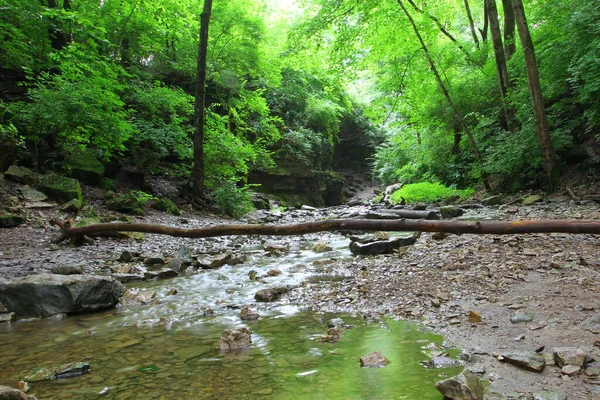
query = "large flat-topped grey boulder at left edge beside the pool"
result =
(0, 274, 125, 318)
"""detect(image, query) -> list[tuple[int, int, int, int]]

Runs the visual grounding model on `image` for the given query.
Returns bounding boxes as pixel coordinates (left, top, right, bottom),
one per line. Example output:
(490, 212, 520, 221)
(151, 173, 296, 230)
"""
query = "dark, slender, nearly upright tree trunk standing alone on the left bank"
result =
(193, 0, 212, 196)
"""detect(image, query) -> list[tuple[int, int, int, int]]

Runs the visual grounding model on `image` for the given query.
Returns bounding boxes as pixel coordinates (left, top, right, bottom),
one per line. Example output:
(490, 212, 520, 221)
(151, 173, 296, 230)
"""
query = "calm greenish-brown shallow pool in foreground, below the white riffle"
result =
(0, 312, 460, 400)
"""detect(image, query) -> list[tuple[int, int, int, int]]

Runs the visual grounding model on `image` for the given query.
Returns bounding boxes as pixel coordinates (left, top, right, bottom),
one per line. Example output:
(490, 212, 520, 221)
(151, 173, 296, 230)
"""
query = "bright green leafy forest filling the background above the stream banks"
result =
(0, 0, 600, 215)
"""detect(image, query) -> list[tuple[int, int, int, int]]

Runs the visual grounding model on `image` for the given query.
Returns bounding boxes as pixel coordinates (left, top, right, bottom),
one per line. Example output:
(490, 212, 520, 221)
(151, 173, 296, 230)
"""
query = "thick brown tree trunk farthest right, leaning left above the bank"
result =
(512, 0, 558, 191)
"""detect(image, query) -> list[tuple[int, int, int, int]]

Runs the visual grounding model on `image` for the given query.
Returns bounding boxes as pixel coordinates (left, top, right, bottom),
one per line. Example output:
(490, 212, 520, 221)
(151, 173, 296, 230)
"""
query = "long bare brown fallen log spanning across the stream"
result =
(51, 219, 600, 243)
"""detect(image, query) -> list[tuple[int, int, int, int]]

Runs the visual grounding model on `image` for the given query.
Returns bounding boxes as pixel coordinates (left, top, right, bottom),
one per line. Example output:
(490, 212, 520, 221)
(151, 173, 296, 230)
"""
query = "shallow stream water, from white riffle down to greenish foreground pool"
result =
(0, 235, 460, 400)
